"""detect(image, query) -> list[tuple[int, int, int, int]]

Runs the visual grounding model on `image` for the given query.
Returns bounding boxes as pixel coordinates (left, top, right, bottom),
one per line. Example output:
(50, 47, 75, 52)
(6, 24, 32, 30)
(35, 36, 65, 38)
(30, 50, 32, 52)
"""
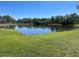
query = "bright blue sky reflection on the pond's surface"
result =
(15, 26, 51, 35)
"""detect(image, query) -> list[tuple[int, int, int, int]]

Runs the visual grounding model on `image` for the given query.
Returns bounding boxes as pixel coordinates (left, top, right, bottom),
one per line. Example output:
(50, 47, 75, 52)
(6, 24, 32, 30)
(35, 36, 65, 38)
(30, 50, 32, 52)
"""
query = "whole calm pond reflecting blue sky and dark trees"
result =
(0, 25, 77, 35)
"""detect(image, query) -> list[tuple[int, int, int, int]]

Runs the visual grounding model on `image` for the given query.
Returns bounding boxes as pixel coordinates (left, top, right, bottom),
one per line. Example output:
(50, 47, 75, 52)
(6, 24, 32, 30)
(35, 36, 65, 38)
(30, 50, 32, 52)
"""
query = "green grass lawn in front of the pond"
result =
(0, 29, 79, 57)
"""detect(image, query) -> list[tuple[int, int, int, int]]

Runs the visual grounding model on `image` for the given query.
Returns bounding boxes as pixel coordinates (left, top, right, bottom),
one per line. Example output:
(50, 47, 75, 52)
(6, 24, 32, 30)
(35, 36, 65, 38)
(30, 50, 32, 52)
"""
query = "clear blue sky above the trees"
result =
(0, 1, 79, 19)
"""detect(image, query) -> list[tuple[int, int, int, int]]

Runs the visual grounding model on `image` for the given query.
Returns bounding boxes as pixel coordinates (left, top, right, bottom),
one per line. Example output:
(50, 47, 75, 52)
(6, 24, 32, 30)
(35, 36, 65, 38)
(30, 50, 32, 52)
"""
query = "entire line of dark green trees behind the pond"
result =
(0, 13, 79, 26)
